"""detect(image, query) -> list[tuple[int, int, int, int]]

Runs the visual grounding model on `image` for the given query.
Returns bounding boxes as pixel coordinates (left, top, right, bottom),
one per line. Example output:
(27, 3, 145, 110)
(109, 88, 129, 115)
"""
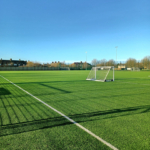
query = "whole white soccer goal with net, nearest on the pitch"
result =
(86, 66, 114, 82)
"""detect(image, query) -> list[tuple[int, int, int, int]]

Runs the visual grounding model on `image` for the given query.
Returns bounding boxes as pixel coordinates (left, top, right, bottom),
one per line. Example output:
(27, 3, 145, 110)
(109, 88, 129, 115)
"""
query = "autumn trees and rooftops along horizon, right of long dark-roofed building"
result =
(26, 56, 150, 70)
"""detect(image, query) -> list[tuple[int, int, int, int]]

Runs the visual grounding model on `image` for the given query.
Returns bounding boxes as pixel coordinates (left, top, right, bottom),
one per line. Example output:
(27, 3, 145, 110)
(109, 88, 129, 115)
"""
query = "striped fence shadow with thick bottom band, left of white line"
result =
(0, 91, 72, 137)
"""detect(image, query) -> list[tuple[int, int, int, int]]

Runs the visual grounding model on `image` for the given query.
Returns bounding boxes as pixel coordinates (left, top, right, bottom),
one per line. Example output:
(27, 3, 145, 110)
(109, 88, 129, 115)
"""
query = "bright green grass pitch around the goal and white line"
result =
(0, 71, 150, 150)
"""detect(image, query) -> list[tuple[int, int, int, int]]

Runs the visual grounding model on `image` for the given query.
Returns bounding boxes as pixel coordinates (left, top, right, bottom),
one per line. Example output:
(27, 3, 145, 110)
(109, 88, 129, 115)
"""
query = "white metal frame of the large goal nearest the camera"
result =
(86, 66, 115, 82)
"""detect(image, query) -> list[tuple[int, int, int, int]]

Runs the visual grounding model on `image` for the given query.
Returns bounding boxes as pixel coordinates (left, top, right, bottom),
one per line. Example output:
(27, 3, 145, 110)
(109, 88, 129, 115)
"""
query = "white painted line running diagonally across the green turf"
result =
(0, 75, 118, 150)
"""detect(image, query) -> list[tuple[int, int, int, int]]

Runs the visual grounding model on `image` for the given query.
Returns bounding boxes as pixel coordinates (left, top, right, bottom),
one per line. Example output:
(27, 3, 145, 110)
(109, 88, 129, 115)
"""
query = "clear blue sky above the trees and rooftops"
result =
(0, 0, 150, 63)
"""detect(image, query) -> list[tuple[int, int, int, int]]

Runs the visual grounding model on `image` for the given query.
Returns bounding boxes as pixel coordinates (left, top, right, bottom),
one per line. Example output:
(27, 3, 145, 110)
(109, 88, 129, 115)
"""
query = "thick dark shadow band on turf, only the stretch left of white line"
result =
(0, 117, 72, 137)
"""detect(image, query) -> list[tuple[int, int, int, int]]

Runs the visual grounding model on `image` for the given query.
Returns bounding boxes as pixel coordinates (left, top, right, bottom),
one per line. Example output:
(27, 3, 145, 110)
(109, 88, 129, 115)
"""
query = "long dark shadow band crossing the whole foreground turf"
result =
(0, 105, 150, 137)
